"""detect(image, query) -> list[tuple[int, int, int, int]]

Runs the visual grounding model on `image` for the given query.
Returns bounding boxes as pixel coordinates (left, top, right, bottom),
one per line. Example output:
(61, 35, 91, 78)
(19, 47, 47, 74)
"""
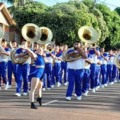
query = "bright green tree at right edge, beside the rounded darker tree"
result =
(96, 4, 120, 50)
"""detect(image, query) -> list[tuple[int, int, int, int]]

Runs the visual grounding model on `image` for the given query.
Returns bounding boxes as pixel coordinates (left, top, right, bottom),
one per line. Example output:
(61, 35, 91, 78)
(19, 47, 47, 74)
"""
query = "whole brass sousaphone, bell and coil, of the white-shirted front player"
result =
(62, 26, 98, 62)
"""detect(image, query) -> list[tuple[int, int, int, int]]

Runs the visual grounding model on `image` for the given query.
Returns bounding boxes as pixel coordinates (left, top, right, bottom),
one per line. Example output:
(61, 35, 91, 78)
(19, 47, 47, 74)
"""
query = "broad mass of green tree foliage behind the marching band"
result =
(11, 0, 120, 49)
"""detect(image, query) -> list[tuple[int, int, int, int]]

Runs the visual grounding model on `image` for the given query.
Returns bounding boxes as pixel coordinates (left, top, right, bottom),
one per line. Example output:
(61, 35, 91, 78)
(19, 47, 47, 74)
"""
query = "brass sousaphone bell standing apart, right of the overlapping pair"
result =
(78, 26, 99, 44)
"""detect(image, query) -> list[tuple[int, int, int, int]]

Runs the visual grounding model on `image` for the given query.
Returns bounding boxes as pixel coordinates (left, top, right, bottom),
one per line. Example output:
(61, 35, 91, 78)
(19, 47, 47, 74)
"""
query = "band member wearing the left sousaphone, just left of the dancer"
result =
(15, 40, 31, 97)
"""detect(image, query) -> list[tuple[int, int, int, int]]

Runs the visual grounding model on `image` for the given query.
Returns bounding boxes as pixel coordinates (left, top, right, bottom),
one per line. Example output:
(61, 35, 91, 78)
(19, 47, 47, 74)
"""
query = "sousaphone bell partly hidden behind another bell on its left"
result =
(37, 27, 53, 44)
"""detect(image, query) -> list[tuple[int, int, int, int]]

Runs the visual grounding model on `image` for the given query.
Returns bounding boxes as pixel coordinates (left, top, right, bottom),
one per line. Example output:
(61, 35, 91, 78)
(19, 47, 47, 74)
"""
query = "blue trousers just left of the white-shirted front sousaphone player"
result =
(61, 62, 67, 83)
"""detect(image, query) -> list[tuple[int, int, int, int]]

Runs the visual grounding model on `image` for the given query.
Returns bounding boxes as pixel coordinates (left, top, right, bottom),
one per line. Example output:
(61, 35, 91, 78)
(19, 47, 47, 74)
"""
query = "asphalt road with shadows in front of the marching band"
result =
(0, 83, 120, 120)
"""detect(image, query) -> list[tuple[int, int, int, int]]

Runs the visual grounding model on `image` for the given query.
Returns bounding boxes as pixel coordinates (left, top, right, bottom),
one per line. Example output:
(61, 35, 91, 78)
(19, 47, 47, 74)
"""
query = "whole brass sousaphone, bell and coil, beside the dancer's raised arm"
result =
(10, 23, 41, 64)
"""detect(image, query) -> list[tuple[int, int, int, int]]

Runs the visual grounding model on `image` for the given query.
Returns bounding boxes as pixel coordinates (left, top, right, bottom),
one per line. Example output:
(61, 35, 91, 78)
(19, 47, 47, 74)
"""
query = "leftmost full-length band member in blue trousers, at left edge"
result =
(0, 39, 10, 90)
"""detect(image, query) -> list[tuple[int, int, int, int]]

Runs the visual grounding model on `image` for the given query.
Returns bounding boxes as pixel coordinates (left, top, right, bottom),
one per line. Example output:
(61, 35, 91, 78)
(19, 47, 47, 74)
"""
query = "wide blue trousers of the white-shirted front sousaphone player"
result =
(66, 69, 84, 97)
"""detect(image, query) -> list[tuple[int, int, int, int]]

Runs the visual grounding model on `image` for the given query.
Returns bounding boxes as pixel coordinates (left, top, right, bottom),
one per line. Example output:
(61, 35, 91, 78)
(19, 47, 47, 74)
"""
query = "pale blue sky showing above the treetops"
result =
(0, 0, 120, 10)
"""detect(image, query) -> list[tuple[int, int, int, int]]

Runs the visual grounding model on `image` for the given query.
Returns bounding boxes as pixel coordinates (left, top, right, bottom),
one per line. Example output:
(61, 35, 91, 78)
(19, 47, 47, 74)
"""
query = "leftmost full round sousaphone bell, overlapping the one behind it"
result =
(22, 23, 41, 42)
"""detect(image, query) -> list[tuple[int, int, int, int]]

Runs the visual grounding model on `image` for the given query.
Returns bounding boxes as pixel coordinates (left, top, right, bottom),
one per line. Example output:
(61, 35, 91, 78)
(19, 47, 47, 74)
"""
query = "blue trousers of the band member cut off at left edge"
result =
(0, 62, 7, 87)
